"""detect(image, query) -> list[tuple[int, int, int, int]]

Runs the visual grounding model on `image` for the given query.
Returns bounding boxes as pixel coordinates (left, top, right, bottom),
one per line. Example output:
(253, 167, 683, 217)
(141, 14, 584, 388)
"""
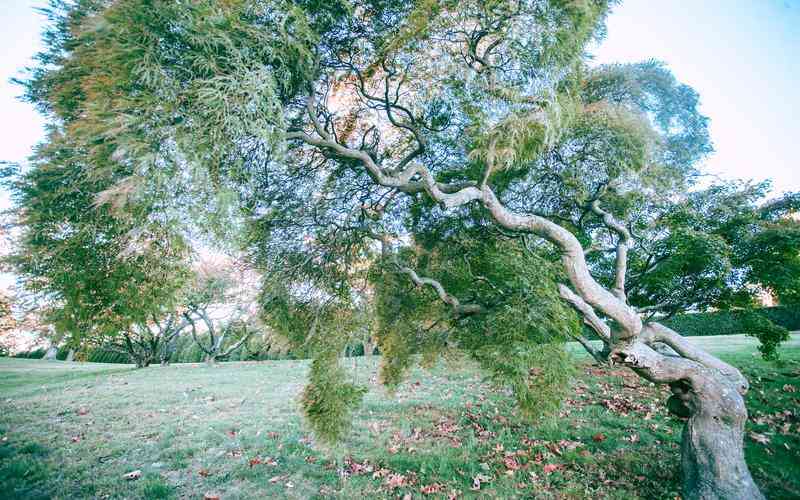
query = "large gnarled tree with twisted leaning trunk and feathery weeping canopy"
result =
(15, 0, 788, 498)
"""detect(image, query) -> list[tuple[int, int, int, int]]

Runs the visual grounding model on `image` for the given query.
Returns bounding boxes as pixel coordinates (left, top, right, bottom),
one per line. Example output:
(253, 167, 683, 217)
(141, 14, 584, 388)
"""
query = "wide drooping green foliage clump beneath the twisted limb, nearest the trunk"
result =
(372, 233, 579, 417)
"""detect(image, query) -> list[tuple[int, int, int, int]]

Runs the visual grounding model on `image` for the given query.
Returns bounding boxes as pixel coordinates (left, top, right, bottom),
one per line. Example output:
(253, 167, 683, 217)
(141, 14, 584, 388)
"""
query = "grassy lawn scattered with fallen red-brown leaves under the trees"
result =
(0, 335, 800, 499)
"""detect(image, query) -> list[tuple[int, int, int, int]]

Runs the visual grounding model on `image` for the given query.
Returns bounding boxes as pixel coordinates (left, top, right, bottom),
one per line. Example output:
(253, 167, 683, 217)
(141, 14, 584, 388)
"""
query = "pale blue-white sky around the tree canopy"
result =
(0, 0, 800, 203)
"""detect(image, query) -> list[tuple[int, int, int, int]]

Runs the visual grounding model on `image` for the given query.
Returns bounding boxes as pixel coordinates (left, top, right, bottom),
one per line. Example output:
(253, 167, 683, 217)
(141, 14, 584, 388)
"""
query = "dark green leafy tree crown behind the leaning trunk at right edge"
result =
(620, 183, 800, 322)
